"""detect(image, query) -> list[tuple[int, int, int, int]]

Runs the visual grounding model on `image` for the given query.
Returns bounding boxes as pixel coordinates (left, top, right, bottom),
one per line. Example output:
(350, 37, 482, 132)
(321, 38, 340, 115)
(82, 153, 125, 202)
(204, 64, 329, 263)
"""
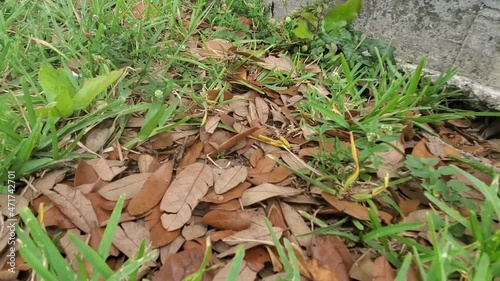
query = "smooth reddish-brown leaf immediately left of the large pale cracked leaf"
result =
(127, 161, 174, 216)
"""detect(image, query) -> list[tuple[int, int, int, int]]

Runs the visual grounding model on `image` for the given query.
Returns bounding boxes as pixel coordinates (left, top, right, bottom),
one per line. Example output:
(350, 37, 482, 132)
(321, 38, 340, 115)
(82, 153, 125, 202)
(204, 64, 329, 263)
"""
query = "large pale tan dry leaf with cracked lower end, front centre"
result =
(160, 163, 213, 231)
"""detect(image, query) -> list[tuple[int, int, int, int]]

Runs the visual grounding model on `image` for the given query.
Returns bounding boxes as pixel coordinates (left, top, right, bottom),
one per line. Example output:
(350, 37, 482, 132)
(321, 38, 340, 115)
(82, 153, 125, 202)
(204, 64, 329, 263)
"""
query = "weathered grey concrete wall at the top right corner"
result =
(265, 0, 500, 90)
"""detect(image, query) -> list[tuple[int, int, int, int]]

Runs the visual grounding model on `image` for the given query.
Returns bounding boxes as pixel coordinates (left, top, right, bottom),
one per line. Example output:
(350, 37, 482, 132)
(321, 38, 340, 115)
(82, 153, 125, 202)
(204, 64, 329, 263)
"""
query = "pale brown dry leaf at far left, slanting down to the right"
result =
(42, 184, 98, 233)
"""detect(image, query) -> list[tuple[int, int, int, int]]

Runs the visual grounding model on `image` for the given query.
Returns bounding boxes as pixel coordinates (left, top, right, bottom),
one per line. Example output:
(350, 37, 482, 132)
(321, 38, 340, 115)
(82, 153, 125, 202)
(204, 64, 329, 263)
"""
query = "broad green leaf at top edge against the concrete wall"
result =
(323, 0, 362, 32)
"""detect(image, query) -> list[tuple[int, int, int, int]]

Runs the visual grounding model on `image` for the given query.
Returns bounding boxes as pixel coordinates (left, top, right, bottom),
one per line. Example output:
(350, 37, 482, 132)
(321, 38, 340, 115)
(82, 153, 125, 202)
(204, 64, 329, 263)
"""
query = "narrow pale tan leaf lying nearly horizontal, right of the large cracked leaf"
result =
(241, 183, 301, 206)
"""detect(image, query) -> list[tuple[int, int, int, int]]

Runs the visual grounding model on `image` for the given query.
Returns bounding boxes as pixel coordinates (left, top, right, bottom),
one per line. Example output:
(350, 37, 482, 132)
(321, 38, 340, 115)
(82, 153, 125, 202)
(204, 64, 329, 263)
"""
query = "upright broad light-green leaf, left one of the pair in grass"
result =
(38, 64, 76, 102)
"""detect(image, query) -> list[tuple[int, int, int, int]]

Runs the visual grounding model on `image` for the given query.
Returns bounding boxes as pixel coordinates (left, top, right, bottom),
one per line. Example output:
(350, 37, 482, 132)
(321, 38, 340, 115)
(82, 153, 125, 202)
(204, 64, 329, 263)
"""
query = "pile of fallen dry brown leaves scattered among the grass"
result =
(0, 9, 498, 281)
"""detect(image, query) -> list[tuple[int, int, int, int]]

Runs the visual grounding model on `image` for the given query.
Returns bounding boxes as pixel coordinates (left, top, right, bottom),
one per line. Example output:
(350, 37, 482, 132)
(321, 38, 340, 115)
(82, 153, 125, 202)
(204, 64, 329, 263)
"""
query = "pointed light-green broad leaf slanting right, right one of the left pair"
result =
(73, 70, 123, 110)
